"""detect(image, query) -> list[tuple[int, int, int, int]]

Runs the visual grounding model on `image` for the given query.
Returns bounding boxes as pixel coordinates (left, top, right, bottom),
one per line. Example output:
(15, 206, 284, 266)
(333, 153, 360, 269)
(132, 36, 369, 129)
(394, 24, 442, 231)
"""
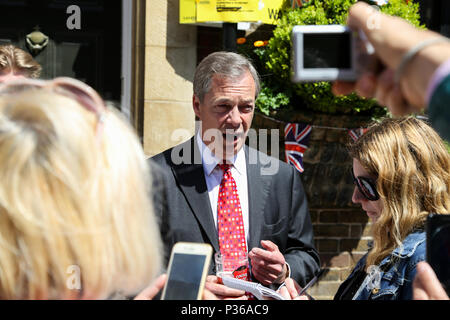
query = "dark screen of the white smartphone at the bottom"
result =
(164, 253, 206, 300)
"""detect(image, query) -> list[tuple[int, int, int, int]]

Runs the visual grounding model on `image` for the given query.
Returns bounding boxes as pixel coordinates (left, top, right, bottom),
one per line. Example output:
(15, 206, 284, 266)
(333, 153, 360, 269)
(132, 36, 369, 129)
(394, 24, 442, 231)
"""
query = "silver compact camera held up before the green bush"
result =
(291, 25, 358, 82)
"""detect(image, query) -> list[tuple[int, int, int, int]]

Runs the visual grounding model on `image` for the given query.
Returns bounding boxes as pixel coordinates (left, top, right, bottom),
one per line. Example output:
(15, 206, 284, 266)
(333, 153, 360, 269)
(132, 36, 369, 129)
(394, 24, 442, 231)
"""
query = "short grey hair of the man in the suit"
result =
(194, 51, 261, 101)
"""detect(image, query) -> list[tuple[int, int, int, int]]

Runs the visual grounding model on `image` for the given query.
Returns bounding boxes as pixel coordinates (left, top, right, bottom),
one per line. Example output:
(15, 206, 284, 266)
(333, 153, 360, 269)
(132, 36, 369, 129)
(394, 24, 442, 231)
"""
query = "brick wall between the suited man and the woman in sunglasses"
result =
(253, 113, 371, 300)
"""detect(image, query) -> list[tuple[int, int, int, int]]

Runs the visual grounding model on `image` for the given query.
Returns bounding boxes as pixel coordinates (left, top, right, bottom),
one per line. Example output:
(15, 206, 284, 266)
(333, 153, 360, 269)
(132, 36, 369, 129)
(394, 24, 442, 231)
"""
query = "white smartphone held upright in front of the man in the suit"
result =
(161, 242, 212, 300)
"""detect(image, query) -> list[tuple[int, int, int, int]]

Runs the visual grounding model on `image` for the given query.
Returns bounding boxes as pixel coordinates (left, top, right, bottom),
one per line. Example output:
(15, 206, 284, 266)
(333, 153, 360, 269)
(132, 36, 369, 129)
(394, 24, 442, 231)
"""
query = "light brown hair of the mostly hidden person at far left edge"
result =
(0, 45, 42, 79)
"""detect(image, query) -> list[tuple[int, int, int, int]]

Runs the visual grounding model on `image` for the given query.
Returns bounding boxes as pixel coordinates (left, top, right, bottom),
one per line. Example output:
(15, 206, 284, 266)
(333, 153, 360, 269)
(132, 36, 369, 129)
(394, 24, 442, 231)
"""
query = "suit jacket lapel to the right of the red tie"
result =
(245, 146, 270, 251)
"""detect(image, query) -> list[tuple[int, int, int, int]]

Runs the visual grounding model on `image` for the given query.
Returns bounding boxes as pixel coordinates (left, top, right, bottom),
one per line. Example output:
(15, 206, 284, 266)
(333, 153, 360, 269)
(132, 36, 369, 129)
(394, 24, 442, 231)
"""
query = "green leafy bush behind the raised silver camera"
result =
(253, 0, 420, 117)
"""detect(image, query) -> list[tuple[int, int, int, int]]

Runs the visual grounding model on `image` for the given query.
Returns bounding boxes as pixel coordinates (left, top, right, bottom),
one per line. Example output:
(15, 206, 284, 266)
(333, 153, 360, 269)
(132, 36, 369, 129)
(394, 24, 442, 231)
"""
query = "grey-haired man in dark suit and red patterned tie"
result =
(150, 52, 319, 296)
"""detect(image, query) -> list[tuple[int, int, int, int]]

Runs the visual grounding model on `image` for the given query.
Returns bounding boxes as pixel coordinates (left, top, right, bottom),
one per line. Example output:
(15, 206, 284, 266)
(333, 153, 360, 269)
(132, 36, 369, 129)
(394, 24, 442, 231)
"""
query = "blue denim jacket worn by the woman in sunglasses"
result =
(348, 231, 426, 300)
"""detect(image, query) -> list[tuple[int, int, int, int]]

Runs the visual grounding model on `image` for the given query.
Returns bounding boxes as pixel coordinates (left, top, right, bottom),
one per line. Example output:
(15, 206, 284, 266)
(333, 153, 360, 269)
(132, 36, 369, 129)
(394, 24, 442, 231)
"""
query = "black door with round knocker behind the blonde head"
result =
(0, 0, 122, 103)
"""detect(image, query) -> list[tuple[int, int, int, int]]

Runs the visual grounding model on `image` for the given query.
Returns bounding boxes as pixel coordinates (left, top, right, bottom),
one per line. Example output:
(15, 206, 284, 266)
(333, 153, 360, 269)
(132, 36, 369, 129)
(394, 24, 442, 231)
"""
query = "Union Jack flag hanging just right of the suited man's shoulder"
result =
(284, 123, 311, 172)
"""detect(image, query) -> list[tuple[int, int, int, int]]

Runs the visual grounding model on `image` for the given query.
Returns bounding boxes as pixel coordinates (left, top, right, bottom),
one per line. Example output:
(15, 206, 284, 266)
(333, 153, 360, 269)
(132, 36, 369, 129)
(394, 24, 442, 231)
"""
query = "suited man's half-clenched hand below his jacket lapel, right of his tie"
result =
(248, 240, 287, 286)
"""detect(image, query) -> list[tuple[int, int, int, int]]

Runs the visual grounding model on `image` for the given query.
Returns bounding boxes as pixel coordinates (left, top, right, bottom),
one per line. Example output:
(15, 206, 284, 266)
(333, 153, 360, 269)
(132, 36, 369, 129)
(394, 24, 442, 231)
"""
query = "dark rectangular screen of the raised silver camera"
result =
(303, 32, 352, 69)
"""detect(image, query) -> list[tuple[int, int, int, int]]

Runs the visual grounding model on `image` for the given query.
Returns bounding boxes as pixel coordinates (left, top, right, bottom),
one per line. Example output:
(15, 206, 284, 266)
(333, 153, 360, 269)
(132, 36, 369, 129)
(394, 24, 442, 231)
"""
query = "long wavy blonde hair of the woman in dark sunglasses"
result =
(350, 117, 450, 267)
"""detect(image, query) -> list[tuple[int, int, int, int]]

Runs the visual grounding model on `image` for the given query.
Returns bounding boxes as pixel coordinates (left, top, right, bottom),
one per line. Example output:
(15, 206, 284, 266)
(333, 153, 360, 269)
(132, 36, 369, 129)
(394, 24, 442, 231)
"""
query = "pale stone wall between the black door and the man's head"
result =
(143, 0, 197, 156)
